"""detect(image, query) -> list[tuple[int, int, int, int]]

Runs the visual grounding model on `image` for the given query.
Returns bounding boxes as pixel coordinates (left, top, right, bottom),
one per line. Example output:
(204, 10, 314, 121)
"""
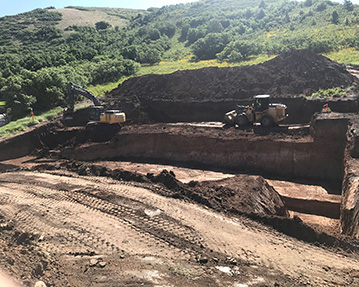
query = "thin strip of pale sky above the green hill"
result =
(0, 0, 359, 17)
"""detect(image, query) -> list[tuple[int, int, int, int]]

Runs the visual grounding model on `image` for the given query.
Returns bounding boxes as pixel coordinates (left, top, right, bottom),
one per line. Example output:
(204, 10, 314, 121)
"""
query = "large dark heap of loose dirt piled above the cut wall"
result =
(106, 50, 358, 112)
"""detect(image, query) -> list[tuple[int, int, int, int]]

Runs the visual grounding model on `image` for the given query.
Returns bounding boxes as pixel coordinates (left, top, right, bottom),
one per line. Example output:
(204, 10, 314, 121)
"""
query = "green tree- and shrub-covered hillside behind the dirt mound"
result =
(0, 0, 359, 119)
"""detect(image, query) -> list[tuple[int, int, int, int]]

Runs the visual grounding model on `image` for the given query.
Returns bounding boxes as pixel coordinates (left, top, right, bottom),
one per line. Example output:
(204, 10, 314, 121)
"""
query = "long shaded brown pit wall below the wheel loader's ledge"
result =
(62, 117, 346, 187)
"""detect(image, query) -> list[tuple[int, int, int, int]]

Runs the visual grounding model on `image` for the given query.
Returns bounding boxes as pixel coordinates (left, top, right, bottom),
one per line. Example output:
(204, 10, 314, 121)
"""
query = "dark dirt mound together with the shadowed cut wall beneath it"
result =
(106, 50, 358, 123)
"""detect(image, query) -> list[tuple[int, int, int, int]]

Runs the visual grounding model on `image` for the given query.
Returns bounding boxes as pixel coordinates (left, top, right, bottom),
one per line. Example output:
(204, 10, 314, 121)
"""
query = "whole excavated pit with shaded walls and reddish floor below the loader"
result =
(2, 113, 357, 236)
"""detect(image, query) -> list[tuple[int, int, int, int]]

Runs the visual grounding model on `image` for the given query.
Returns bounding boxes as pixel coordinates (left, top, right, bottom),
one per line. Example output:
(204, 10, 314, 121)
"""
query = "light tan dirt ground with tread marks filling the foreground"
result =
(0, 172, 359, 286)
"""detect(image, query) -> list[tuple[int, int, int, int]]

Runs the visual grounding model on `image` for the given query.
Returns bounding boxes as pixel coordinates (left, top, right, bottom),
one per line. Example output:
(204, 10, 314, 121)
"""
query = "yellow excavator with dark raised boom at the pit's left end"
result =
(63, 82, 126, 140)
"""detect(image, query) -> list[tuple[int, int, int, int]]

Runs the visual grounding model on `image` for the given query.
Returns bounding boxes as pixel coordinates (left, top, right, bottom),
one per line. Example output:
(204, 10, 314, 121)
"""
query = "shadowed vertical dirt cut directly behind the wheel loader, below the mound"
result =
(116, 97, 359, 124)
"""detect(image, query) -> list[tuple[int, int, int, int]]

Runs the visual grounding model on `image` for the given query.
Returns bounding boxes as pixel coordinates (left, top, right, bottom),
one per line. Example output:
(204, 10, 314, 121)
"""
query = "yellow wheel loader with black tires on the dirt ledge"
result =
(223, 95, 288, 127)
